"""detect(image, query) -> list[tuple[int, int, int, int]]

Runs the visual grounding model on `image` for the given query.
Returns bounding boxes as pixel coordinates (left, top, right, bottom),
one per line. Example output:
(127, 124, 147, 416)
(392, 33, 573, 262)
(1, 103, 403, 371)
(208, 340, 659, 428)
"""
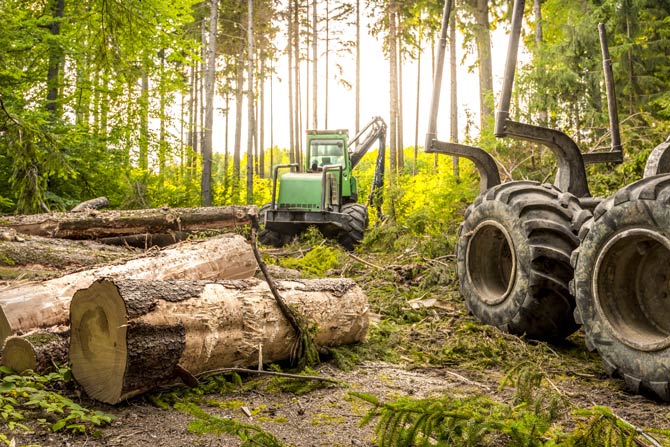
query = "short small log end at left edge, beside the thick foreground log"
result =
(2, 326, 70, 374)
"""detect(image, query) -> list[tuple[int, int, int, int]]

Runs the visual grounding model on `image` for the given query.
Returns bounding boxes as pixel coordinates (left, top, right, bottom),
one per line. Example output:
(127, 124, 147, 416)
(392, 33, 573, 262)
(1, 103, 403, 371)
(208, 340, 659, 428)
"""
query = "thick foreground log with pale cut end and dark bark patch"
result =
(70, 278, 368, 404)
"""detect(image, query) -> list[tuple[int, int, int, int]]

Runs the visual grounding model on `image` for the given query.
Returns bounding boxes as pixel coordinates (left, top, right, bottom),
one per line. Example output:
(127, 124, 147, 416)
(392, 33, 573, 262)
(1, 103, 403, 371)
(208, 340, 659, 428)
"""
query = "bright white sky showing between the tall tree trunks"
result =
(213, 5, 508, 152)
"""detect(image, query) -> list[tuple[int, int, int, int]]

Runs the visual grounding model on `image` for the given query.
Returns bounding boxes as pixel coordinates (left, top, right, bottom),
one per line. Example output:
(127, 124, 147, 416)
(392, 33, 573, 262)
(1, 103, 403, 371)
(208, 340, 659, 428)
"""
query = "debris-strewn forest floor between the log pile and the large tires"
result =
(0, 234, 670, 447)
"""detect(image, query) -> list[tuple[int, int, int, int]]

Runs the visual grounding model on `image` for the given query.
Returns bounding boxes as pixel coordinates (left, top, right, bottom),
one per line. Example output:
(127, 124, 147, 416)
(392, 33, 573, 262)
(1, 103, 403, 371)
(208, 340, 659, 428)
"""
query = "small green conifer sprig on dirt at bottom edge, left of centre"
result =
(174, 403, 282, 447)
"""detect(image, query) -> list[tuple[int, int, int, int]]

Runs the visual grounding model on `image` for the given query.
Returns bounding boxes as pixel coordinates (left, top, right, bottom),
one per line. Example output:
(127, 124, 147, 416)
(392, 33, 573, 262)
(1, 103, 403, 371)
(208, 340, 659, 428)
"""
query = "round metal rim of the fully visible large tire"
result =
(465, 220, 516, 305)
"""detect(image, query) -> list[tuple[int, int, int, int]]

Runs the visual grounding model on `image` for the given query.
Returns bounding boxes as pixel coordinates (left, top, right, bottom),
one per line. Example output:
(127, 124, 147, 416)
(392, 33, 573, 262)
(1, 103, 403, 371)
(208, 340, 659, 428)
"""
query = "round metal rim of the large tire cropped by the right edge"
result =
(593, 228, 670, 351)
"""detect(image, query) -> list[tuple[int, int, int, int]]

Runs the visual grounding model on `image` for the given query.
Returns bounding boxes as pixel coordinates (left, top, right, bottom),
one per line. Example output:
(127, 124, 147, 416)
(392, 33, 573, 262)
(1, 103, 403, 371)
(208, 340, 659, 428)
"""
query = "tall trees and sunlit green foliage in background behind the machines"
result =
(0, 0, 670, 213)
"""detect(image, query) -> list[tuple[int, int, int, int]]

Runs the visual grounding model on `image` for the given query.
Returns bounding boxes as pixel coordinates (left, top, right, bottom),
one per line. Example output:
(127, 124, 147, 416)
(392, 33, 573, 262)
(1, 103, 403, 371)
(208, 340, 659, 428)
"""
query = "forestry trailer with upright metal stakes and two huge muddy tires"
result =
(425, 0, 670, 401)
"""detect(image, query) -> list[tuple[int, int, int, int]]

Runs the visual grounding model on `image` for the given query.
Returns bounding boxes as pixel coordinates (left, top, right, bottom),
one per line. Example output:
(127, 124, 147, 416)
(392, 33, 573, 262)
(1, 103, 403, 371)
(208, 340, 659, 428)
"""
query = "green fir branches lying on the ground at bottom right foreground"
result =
(350, 362, 670, 447)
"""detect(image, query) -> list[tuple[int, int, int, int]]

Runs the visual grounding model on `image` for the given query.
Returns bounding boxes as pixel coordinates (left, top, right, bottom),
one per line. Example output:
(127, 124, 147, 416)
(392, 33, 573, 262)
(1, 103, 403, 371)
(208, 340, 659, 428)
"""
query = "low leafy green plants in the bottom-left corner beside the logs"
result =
(0, 367, 112, 433)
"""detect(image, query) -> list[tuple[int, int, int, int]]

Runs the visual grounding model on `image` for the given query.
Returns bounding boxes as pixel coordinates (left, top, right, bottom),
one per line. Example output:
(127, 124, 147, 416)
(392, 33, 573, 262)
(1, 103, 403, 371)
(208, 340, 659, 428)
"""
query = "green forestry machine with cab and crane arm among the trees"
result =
(258, 117, 386, 250)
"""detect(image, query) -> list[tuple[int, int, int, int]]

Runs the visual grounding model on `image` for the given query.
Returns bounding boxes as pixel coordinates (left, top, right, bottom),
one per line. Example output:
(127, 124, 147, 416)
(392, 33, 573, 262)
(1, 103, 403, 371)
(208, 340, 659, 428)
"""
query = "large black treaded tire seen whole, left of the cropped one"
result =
(456, 181, 591, 340)
